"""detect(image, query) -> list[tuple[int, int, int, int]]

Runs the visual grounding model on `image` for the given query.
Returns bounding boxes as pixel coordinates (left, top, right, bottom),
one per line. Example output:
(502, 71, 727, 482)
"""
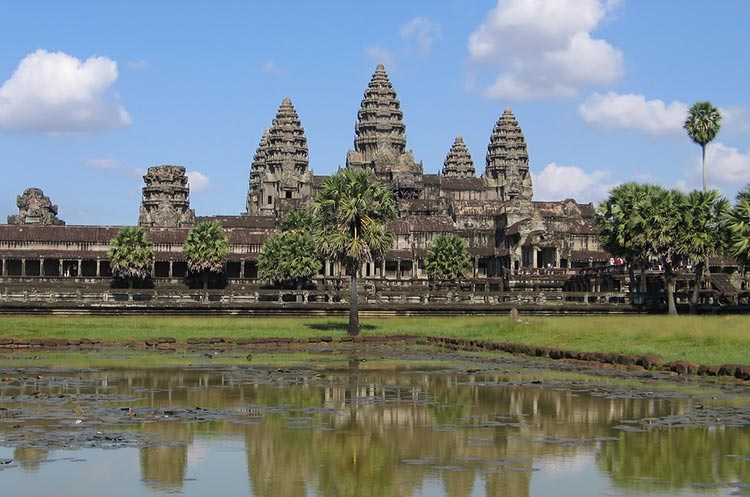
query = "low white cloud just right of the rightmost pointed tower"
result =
(532, 162, 613, 202)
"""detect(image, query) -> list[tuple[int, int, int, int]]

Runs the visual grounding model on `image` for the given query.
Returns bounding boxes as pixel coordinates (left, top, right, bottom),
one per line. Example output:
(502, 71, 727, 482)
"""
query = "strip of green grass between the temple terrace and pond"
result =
(0, 316, 750, 364)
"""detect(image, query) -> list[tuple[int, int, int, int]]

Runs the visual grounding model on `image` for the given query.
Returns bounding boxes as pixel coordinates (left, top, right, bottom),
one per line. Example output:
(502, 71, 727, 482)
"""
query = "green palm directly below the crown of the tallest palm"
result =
(680, 190, 729, 314)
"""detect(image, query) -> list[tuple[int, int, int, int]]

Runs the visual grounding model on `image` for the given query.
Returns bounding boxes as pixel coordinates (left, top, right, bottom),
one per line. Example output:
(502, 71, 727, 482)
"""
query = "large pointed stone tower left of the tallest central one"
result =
(247, 98, 313, 216)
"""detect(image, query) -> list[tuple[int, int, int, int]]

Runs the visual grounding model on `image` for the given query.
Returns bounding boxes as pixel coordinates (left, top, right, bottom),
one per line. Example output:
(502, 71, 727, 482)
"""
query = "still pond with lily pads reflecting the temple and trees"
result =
(0, 361, 750, 497)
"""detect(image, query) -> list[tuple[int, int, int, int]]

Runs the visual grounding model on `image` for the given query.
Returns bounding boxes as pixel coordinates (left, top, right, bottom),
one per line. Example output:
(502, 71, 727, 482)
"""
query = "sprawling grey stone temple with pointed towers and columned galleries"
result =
(0, 65, 610, 288)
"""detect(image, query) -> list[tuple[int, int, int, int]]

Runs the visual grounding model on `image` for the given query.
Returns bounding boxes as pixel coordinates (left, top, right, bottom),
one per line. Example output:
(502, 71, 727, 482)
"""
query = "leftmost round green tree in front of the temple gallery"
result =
(109, 227, 154, 290)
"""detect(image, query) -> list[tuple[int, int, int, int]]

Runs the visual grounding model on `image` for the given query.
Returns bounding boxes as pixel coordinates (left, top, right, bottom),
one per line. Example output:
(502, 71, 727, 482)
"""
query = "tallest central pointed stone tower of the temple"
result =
(346, 64, 423, 199)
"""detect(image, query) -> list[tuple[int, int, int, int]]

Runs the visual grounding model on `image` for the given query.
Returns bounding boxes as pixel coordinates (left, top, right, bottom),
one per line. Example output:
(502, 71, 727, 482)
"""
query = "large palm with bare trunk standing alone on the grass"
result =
(312, 168, 396, 335)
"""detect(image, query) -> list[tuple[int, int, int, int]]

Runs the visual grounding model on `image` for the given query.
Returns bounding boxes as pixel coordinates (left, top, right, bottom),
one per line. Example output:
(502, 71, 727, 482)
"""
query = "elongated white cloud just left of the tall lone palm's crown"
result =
(578, 92, 688, 136)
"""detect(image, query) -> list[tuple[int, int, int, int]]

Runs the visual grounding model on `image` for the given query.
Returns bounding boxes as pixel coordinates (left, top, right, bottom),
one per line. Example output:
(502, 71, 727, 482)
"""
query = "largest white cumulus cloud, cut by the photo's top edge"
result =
(469, 0, 623, 100)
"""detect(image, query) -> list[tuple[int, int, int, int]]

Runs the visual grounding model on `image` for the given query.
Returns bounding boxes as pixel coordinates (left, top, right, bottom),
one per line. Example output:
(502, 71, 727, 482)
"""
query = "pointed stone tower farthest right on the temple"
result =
(483, 108, 533, 202)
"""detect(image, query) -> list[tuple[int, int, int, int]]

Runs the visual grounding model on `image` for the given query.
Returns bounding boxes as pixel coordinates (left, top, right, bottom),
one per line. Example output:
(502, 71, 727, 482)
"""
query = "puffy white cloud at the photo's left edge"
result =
(0, 50, 131, 134)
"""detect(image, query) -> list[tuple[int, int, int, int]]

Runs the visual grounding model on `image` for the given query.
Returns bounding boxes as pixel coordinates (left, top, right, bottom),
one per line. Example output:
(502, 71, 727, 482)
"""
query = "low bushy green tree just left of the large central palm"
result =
(258, 231, 323, 289)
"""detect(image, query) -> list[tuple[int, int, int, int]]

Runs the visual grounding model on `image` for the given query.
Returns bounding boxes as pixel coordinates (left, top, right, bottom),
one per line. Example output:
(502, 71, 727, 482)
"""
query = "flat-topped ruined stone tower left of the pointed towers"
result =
(138, 166, 195, 228)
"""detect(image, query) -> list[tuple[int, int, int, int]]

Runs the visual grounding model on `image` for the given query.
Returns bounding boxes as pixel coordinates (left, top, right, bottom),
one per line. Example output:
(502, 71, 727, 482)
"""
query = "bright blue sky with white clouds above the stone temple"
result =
(0, 0, 750, 225)
